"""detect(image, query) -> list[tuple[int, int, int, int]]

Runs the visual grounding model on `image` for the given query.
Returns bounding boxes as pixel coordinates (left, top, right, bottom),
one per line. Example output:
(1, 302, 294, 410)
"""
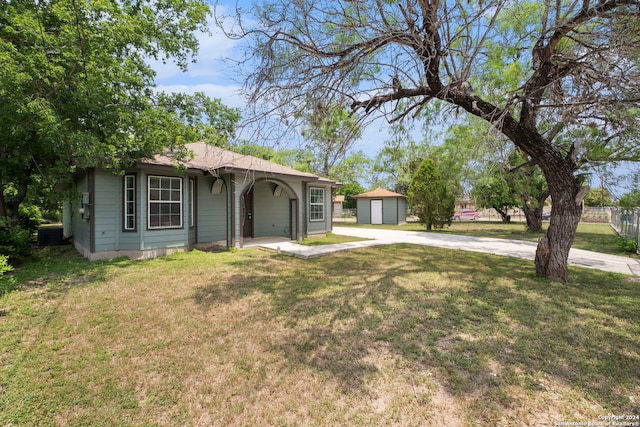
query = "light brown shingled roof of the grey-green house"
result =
(143, 142, 333, 183)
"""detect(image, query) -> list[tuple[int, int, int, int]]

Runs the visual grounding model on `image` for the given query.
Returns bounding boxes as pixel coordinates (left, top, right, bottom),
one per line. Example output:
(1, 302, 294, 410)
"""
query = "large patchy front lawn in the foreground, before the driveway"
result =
(0, 245, 640, 426)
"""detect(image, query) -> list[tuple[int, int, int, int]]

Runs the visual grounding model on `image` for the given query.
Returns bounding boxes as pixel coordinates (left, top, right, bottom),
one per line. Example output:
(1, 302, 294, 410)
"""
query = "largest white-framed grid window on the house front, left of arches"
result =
(148, 176, 182, 228)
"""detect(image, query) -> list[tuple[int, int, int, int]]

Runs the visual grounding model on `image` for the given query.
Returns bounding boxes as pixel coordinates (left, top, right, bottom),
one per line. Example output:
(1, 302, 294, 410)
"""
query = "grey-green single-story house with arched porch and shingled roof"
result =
(63, 143, 336, 260)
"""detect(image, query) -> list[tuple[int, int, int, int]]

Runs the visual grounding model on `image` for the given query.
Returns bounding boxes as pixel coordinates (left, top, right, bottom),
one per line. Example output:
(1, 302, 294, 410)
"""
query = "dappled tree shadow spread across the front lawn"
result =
(195, 245, 640, 420)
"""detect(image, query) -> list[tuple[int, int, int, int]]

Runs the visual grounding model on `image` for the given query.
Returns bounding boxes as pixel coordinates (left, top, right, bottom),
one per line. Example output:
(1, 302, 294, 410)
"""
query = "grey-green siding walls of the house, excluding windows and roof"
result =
(65, 169, 332, 258)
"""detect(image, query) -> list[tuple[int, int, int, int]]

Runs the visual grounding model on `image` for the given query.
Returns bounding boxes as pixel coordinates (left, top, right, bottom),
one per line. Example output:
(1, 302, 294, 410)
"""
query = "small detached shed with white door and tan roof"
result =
(353, 188, 407, 225)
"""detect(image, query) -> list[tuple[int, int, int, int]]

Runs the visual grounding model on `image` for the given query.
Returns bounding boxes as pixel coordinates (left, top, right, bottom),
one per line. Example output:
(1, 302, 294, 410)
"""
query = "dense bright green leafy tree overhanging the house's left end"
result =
(0, 0, 239, 224)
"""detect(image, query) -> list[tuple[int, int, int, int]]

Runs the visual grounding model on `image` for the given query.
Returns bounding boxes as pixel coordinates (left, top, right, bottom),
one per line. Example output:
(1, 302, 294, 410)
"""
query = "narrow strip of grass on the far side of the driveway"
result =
(333, 221, 634, 256)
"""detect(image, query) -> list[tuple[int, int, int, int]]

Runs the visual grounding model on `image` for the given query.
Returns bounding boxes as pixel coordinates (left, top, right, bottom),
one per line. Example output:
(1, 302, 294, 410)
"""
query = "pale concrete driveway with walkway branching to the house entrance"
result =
(261, 227, 640, 276)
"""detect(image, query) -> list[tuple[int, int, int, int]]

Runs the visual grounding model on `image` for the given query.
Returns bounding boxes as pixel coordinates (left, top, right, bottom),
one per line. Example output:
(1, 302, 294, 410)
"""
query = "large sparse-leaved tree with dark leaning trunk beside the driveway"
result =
(219, 0, 640, 280)
